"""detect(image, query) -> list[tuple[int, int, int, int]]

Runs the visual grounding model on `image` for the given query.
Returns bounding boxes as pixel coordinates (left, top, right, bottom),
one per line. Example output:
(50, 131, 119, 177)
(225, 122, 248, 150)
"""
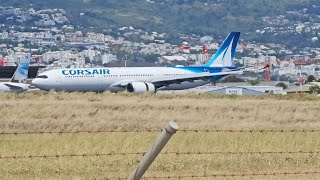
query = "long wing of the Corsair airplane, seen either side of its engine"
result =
(112, 70, 243, 88)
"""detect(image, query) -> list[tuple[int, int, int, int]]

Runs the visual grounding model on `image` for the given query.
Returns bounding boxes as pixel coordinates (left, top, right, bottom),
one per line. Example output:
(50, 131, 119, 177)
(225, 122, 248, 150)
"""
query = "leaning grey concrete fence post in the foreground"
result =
(128, 121, 179, 180)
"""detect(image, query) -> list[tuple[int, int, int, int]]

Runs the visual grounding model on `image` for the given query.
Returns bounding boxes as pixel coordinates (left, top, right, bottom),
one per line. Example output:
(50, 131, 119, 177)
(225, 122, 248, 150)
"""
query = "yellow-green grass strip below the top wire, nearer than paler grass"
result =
(0, 132, 320, 178)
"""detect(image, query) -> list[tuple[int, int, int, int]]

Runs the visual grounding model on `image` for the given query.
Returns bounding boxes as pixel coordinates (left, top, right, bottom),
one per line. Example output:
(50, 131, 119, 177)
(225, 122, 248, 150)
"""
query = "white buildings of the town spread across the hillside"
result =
(0, 5, 320, 81)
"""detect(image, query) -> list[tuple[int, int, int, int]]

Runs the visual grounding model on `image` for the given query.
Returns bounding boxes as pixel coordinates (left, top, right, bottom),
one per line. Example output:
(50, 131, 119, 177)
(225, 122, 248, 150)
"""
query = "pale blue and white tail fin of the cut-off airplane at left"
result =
(10, 53, 30, 83)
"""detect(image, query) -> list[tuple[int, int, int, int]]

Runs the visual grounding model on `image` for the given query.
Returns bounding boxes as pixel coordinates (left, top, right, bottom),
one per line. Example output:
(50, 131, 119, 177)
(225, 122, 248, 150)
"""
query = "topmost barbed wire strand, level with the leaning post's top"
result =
(0, 129, 320, 135)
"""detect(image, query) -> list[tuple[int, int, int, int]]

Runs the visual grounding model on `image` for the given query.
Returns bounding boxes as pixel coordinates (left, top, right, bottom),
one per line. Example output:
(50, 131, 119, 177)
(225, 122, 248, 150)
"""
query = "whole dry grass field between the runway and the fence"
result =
(0, 93, 320, 179)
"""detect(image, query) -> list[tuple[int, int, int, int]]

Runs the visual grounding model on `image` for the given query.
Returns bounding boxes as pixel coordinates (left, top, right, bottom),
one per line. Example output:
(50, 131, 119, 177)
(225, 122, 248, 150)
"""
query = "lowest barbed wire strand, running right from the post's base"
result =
(142, 171, 320, 179)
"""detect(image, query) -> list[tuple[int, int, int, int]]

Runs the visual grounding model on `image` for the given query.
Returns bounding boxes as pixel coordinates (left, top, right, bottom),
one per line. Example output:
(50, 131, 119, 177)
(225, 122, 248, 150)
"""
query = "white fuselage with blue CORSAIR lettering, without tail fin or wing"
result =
(32, 67, 218, 92)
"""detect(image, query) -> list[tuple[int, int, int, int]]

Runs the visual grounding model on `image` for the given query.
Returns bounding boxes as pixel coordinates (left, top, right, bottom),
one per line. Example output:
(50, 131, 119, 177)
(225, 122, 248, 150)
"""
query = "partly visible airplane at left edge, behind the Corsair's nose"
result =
(0, 55, 30, 92)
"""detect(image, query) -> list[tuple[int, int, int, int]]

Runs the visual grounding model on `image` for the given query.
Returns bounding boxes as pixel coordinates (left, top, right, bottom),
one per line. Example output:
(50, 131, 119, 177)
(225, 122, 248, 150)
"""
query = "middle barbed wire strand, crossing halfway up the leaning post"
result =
(0, 151, 320, 159)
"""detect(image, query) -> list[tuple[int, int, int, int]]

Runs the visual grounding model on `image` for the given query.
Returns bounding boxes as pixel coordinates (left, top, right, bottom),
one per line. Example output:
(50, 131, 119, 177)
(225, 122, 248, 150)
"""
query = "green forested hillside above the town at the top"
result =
(0, 0, 320, 46)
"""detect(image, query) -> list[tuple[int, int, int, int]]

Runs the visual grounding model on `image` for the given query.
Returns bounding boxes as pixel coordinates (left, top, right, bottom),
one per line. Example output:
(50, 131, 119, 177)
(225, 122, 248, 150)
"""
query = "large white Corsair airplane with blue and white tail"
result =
(32, 32, 244, 93)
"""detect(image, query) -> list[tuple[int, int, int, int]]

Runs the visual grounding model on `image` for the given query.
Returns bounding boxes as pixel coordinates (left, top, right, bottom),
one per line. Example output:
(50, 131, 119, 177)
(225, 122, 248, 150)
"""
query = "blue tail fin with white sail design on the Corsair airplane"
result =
(204, 32, 240, 67)
